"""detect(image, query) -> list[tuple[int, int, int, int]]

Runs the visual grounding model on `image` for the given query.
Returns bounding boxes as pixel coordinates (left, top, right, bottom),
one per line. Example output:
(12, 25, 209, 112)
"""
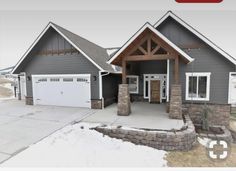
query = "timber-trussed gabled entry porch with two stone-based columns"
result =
(109, 23, 193, 118)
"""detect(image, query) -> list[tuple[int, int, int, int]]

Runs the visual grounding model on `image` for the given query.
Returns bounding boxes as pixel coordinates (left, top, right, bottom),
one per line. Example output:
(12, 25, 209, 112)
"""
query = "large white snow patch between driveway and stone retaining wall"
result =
(1, 123, 167, 167)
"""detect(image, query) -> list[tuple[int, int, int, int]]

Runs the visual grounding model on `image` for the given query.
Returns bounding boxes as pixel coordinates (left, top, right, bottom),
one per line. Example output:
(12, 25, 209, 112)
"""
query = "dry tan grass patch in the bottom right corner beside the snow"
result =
(165, 143, 236, 167)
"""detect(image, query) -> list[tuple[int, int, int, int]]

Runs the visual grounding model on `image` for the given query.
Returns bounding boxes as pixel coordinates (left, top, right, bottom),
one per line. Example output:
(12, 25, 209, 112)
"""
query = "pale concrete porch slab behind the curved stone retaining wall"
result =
(83, 102, 184, 130)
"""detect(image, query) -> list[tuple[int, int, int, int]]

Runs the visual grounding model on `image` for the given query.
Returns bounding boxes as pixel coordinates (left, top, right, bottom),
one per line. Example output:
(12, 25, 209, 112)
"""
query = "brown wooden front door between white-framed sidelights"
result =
(150, 80, 161, 103)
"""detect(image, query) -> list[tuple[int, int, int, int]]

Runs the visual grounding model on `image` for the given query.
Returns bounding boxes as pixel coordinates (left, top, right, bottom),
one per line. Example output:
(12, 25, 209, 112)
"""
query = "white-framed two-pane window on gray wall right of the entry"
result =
(186, 73, 211, 101)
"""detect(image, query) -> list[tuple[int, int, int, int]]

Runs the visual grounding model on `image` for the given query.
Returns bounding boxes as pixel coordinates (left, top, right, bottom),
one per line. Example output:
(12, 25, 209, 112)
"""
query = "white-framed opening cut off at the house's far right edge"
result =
(229, 73, 236, 104)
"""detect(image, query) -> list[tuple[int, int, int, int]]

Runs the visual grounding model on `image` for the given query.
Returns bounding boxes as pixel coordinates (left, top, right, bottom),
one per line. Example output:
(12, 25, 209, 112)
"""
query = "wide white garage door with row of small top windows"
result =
(32, 74, 91, 108)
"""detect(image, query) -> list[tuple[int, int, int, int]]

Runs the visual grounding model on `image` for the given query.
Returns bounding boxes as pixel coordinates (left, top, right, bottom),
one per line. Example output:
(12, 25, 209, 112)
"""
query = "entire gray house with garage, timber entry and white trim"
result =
(13, 11, 236, 125)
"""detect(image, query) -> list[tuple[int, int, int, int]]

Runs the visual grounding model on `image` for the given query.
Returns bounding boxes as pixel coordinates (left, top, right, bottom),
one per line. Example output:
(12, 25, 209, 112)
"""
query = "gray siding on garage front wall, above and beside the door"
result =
(16, 28, 99, 99)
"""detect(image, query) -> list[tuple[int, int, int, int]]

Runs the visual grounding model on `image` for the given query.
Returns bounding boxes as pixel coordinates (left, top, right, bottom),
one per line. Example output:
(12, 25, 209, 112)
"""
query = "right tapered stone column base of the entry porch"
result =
(169, 84, 182, 119)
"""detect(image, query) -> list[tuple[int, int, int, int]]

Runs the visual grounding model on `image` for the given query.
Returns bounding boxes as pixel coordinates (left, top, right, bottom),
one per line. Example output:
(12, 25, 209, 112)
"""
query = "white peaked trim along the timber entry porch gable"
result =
(108, 23, 194, 64)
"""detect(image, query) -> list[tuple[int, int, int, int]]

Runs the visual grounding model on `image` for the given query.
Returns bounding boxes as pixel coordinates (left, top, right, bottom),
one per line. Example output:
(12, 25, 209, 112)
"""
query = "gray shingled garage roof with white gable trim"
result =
(12, 22, 114, 74)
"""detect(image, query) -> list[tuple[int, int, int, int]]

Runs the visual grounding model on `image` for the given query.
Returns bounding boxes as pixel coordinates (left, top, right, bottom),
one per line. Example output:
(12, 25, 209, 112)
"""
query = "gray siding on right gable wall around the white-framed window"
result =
(157, 19, 235, 104)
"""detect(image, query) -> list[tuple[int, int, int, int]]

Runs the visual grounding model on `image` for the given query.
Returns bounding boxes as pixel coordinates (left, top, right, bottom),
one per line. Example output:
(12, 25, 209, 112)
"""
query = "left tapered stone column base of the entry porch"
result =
(117, 84, 131, 116)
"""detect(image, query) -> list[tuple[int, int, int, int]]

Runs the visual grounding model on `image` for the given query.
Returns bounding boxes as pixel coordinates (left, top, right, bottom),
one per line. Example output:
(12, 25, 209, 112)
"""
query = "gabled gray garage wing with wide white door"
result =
(12, 22, 121, 108)
